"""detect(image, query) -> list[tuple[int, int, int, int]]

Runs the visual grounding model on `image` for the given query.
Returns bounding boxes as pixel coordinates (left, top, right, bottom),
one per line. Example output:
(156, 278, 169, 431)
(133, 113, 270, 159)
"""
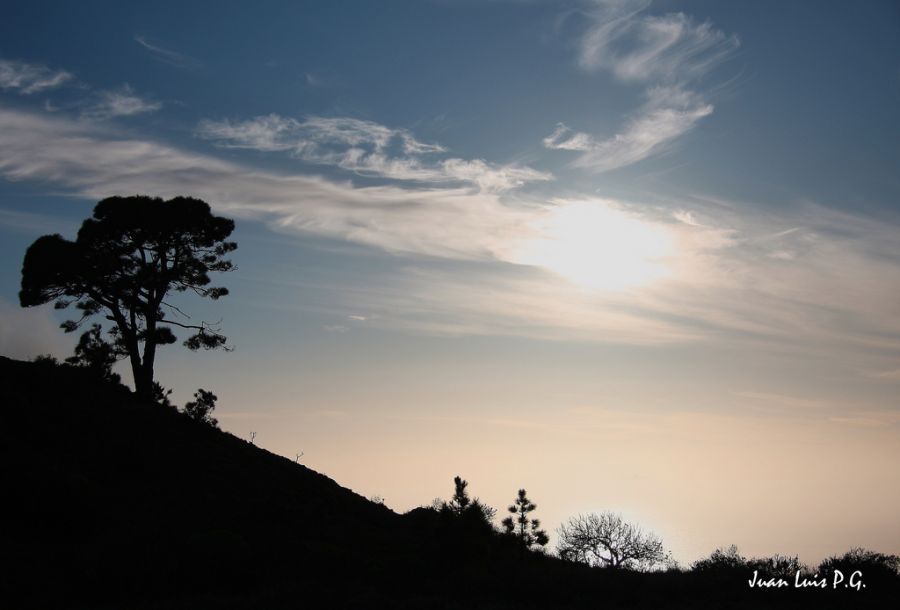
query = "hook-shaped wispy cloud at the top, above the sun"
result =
(543, 0, 739, 173)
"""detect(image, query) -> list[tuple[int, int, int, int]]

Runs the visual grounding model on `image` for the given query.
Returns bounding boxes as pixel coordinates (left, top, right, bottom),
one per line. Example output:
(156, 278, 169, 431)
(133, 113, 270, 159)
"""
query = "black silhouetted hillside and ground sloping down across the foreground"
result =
(0, 358, 900, 610)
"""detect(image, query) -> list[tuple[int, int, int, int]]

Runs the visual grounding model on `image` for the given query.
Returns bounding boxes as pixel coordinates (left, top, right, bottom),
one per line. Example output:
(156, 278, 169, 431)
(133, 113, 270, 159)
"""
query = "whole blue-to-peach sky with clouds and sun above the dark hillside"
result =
(0, 0, 900, 565)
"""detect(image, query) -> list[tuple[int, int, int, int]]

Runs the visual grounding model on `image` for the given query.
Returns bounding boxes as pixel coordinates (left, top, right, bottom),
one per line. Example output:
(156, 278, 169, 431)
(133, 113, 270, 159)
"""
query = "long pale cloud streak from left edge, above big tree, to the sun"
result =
(0, 102, 529, 260)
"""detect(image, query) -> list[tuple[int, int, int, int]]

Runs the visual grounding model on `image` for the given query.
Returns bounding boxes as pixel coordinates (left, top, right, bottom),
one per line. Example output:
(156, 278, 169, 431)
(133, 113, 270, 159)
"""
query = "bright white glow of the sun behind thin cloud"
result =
(515, 201, 673, 291)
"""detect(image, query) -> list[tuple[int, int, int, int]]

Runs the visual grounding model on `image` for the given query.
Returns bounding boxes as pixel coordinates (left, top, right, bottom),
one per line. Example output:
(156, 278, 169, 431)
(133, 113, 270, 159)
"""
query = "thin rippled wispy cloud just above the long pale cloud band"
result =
(196, 114, 552, 191)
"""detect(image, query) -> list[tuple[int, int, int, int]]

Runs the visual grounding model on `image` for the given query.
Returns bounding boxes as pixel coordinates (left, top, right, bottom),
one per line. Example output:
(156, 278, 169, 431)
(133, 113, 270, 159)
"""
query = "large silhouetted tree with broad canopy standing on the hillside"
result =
(19, 195, 237, 399)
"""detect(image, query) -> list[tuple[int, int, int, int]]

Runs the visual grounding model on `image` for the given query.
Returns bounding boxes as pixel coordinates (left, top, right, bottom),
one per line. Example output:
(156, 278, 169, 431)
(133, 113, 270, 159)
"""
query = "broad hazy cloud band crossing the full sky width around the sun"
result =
(0, 101, 900, 360)
